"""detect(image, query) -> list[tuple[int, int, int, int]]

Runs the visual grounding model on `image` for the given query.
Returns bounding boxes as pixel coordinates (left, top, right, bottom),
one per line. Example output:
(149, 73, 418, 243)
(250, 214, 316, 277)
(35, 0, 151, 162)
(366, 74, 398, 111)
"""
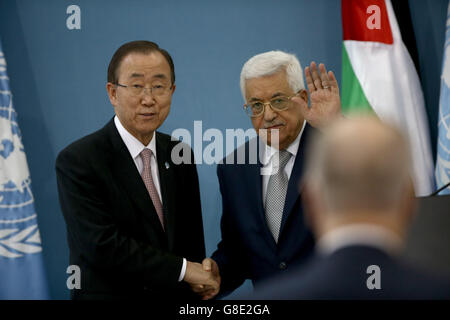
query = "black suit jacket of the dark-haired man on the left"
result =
(56, 120, 205, 299)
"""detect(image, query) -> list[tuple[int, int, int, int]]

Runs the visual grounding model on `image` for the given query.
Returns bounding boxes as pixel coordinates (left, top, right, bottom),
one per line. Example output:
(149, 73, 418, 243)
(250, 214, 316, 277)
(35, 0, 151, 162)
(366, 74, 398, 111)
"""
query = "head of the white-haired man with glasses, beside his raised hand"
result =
(240, 51, 308, 149)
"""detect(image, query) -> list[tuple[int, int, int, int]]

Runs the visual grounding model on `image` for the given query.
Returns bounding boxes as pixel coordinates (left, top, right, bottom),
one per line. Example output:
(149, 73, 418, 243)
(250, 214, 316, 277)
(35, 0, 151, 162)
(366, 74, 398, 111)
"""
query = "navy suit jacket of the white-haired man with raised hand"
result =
(212, 124, 314, 295)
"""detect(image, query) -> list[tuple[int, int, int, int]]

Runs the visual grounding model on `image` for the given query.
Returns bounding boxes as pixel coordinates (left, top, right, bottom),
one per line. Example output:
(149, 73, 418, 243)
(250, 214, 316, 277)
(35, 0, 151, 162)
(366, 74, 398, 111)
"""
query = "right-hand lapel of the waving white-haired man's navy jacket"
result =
(280, 123, 312, 235)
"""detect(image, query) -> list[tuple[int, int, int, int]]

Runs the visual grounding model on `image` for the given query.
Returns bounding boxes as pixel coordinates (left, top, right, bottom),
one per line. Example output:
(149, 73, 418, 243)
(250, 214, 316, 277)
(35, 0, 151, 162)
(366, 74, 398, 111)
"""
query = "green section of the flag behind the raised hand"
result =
(341, 44, 375, 115)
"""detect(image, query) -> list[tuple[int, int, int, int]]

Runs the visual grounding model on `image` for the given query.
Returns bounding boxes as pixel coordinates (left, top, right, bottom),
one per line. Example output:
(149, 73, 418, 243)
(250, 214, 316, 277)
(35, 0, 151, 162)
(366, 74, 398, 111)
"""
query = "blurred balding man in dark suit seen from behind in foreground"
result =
(251, 118, 450, 299)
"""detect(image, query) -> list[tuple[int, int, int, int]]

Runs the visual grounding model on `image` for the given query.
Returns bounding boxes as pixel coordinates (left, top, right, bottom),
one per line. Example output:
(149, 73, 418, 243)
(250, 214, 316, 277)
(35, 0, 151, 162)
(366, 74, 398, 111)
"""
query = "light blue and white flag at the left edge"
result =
(0, 39, 49, 299)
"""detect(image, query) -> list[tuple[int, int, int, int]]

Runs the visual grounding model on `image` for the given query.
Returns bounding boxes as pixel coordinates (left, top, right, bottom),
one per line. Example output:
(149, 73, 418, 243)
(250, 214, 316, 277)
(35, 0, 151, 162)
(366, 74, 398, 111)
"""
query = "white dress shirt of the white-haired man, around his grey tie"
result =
(261, 121, 306, 207)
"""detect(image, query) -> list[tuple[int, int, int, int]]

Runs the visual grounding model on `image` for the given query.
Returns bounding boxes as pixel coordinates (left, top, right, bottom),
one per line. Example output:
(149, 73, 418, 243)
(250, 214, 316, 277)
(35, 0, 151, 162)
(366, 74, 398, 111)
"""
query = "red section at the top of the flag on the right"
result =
(341, 0, 394, 44)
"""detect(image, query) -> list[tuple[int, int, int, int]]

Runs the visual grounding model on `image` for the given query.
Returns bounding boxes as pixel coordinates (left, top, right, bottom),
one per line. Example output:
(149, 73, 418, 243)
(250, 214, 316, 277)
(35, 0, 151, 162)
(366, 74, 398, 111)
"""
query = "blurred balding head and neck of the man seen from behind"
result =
(303, 117, 414, 242)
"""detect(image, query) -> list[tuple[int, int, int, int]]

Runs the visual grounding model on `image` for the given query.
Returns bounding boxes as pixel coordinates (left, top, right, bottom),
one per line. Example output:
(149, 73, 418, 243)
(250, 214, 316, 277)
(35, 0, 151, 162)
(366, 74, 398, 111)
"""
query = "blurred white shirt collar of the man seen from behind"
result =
(317, 223, 402, 254)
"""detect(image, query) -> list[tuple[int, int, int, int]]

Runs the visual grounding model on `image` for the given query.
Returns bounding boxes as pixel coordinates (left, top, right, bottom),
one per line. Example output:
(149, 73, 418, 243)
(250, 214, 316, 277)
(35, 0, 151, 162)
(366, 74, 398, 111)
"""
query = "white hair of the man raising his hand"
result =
(240, 50, 305, 100)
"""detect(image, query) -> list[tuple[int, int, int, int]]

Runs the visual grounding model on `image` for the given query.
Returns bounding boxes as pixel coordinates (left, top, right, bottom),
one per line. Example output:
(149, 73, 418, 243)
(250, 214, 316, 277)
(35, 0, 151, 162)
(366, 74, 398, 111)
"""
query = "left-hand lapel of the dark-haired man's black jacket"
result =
(105, 119, 165, 238)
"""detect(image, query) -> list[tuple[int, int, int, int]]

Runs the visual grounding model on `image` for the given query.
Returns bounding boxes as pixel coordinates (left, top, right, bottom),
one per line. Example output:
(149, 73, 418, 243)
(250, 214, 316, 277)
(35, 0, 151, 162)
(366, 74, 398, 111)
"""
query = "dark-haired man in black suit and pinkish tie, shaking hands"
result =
(56, 41, 220, 299)
